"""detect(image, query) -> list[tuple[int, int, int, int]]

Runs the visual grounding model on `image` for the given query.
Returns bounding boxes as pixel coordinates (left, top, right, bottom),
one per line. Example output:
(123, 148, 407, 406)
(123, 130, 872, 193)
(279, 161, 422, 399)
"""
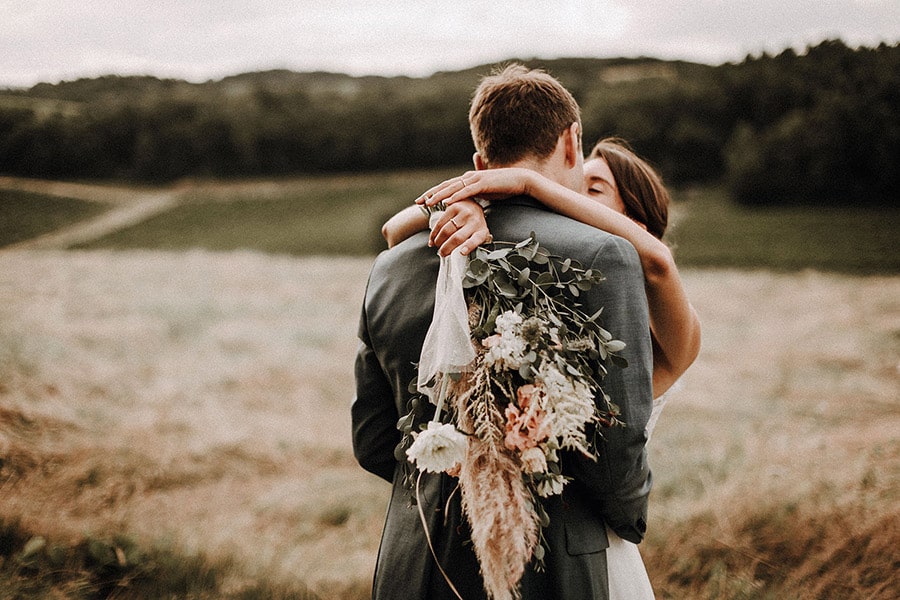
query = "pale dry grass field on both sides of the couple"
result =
(0, 251, 900, 598)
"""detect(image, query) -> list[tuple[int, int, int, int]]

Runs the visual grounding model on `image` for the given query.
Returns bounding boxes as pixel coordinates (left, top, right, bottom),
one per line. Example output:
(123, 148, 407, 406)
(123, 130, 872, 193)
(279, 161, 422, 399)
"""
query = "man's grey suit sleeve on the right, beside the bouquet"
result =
(575, 237, 653, 543)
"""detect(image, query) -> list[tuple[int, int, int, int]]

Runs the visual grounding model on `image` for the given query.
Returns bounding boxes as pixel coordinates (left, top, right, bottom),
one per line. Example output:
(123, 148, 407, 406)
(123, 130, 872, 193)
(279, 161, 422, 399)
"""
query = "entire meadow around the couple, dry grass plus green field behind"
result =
(0, 172, 900, 600)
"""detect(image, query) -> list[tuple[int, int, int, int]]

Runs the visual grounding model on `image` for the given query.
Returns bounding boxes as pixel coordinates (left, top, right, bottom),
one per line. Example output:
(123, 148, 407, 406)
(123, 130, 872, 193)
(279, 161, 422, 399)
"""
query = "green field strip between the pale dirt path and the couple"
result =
(71, 170, 459, 256)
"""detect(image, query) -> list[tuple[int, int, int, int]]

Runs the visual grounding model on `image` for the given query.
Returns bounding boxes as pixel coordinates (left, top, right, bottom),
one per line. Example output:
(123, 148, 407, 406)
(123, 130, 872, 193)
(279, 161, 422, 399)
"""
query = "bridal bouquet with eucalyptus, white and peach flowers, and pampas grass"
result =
(397, 234, 625, 600)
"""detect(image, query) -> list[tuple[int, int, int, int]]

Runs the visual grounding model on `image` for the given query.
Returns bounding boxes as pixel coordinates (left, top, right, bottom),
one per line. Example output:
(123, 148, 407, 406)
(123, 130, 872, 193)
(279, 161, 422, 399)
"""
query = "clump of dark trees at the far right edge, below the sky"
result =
(725, 41, 900, 206)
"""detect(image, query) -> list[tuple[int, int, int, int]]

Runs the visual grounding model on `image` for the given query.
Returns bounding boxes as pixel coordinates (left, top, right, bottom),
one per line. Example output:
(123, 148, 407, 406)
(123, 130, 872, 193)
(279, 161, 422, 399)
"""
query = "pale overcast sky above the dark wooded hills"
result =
(0, 0, 900, 87)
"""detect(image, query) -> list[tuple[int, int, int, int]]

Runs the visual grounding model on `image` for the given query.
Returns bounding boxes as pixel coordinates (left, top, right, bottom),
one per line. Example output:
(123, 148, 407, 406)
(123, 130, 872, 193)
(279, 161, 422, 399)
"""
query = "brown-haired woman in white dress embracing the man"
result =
(382, 138, 700, 600)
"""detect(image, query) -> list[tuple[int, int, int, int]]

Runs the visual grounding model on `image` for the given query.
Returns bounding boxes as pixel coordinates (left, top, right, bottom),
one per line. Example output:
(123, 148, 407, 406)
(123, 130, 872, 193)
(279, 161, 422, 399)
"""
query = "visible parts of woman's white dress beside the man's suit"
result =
(606, 394, 667, 600)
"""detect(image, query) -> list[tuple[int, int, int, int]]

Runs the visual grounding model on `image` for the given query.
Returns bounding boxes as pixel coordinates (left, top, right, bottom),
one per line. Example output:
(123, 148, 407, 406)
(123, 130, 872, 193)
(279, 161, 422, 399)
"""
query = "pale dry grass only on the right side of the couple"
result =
(644, 271, 900, 599)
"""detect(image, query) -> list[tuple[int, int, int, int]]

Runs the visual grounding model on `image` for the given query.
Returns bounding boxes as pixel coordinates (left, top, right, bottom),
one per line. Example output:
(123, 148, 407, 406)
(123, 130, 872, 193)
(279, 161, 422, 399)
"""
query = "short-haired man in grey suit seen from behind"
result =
(352, 66, 652, 600)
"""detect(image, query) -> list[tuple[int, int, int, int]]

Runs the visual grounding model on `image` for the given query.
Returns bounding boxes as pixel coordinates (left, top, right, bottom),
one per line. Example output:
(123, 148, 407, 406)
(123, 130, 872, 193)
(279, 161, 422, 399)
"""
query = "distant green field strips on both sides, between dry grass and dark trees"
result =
(0, 167, 900, 275)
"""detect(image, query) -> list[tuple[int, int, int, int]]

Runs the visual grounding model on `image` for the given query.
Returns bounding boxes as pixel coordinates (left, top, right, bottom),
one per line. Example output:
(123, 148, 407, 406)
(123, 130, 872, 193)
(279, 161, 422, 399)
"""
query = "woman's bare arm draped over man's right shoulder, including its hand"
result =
(418, 169, 700, 397)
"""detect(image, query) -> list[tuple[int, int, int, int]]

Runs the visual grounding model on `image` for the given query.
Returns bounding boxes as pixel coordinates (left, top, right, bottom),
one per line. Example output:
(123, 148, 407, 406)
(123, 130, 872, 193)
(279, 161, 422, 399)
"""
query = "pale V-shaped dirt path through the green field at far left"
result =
(0, 177, 184, 250)
